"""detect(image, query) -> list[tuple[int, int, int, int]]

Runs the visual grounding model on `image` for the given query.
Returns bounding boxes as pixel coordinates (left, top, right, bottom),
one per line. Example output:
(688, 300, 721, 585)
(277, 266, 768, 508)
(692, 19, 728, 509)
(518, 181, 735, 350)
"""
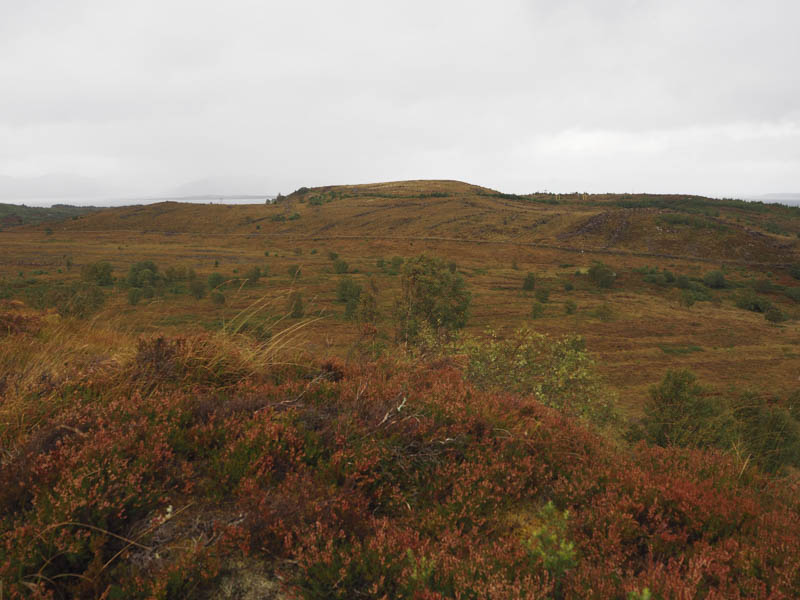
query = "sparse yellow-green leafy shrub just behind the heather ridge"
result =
(457, 327, 614, 423)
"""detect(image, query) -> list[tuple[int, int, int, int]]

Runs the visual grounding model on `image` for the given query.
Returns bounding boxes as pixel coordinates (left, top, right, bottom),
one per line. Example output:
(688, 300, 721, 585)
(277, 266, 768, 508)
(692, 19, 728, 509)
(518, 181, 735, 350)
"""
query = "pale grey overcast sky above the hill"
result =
(0, 0, 800, 201)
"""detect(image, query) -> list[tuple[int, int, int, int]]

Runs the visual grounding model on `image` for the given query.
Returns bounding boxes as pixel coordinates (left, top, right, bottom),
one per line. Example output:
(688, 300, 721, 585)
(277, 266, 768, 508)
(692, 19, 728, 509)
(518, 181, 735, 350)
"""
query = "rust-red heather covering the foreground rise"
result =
(0, 316, 800, 598)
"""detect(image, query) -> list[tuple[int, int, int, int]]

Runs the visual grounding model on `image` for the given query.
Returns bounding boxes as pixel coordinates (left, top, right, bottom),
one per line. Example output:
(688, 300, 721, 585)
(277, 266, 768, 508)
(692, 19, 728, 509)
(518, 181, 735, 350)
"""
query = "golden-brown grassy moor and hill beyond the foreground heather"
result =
(0, 181, 800, 411)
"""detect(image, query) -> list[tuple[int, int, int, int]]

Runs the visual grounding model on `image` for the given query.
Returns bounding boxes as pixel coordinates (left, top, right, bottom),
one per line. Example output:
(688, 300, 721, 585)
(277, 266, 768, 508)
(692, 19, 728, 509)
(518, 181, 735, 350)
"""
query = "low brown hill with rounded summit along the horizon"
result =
(28, 181, 800, 263)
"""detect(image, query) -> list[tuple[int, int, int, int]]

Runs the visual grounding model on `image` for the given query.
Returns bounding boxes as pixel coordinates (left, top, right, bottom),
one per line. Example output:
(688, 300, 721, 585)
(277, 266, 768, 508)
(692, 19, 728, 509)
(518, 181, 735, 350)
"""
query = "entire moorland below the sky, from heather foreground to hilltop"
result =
(0, 181, 800, 598)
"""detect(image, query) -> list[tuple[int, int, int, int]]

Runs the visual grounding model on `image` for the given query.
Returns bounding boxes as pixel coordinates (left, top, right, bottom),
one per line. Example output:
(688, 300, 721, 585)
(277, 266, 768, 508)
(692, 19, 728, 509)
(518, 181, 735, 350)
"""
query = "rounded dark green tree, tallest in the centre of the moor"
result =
(393, 254, 471, 341)
